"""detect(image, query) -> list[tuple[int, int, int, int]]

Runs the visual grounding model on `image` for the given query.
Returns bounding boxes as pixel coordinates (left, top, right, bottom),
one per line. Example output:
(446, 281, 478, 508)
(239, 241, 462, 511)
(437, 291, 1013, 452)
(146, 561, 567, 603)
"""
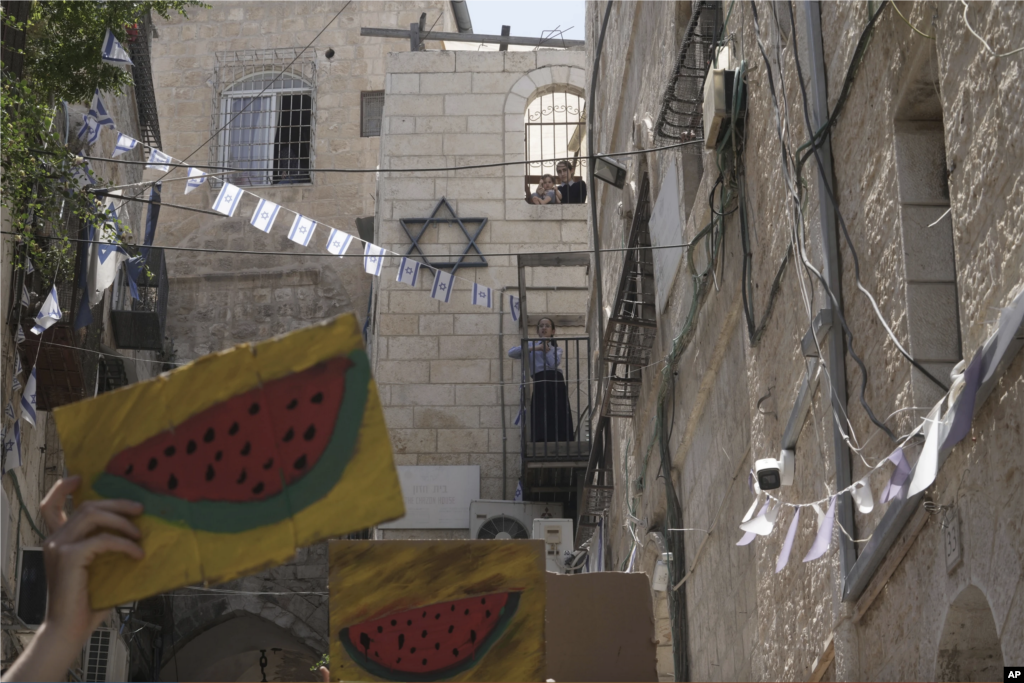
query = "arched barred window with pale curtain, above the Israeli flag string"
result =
(218, 72, 313, 185)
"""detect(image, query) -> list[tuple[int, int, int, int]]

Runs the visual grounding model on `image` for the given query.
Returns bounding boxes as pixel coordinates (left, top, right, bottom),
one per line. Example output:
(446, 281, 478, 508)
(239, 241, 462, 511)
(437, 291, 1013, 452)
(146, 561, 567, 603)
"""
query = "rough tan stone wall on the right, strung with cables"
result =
(588, 0, 1024, 680)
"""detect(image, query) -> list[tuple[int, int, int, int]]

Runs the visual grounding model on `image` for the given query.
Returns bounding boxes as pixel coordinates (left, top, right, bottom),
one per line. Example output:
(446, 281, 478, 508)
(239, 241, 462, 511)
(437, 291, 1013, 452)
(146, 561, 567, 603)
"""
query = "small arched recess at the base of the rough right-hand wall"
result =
(935, 586, 1002, 681)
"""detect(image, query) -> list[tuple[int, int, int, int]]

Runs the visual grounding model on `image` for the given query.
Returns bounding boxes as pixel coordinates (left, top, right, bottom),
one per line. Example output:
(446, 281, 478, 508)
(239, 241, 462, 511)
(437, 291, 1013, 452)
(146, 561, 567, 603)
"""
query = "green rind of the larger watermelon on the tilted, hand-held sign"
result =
(92, 350, 370, 533)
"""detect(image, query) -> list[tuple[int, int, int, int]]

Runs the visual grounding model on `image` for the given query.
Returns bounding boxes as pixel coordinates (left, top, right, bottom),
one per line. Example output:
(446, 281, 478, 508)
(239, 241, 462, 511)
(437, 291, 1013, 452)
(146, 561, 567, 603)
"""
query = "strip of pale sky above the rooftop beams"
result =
(467, 0, 586, 40)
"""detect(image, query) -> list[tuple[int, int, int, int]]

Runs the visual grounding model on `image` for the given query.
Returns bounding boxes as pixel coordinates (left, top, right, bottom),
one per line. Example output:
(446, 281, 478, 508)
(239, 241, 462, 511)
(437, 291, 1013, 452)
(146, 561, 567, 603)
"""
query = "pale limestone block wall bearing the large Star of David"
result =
(373, 49, 589, 524)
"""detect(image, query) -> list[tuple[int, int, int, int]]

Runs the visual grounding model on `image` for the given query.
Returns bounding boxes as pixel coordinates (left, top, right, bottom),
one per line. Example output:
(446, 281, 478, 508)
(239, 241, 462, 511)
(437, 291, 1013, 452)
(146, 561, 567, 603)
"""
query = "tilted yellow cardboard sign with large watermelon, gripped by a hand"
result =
(54, 315, 404, 609)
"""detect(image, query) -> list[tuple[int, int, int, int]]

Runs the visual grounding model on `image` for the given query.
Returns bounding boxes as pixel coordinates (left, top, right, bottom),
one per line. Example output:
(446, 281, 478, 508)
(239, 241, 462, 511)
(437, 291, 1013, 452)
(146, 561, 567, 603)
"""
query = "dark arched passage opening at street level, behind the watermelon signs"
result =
(161, 614, 321, 681)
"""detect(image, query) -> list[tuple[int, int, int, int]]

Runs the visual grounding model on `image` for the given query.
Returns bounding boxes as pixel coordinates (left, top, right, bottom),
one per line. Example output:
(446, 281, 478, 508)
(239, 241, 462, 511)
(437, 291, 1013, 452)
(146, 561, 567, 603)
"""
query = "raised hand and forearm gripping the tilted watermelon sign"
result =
(2, 476, 143, 681)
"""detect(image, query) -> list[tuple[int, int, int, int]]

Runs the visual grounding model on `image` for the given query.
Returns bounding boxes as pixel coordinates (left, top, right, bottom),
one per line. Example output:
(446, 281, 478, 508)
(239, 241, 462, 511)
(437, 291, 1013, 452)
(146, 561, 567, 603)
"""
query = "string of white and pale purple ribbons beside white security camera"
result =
(736, 292, 1024, 573)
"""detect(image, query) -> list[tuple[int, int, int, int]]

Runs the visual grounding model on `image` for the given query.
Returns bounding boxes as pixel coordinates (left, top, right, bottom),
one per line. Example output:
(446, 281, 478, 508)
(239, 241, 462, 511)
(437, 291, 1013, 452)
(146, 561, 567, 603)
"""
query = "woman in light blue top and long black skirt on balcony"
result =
(509, 317, 573, 441)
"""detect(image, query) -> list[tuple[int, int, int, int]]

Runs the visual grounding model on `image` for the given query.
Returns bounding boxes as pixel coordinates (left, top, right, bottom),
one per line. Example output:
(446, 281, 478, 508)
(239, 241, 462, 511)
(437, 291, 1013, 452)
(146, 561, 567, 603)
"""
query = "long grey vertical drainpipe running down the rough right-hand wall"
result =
(804, 0, 857, 588)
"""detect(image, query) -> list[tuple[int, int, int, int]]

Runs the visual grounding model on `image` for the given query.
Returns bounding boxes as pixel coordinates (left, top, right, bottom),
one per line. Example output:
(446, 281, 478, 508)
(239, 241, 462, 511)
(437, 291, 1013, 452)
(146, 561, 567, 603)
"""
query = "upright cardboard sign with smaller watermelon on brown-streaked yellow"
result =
(330, 541, 547, 681)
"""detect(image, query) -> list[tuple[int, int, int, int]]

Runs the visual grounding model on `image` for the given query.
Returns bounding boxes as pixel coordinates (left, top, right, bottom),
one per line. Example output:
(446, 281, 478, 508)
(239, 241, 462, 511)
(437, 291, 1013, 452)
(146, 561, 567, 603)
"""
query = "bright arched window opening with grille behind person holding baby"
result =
(525, 90, 588, 201)
